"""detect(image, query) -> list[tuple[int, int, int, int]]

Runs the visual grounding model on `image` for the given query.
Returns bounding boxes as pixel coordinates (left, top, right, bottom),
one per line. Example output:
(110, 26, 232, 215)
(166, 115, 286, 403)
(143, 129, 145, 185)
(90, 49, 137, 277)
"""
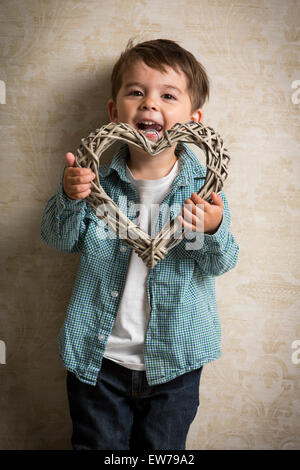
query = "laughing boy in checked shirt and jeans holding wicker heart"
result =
(41, 39, 238, 450)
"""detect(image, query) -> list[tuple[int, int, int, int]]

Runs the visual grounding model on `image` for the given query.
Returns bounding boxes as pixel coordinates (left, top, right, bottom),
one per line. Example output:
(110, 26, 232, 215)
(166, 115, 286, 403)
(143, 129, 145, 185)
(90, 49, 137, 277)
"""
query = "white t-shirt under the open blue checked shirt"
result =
(104, 159, 180, 370)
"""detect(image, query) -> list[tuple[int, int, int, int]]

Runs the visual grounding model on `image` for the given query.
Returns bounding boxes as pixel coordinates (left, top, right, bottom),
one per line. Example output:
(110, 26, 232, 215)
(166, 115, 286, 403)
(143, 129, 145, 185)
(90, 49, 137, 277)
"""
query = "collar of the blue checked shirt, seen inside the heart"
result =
(99, 142, 206, 186)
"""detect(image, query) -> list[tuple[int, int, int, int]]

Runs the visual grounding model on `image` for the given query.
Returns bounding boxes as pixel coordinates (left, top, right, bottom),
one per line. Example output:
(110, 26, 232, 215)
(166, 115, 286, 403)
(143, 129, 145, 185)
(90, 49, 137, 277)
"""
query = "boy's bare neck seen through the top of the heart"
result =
(126, 144, 179, 180)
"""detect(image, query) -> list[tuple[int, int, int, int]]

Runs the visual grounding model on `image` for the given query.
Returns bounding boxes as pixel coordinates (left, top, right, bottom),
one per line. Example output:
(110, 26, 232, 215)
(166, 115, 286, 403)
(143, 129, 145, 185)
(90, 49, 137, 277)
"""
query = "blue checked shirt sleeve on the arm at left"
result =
(41, 167, 87, 253)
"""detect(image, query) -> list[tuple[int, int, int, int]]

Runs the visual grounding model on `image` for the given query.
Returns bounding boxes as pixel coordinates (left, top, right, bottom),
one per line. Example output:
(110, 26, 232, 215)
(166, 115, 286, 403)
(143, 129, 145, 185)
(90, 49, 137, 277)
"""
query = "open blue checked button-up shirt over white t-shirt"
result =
(41, 143, 239, 385)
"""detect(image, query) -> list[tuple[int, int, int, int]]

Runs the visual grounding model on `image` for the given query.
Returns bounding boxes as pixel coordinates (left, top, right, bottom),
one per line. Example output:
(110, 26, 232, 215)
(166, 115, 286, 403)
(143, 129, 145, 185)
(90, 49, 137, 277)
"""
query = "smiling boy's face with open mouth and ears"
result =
(107, 61, 202, 137)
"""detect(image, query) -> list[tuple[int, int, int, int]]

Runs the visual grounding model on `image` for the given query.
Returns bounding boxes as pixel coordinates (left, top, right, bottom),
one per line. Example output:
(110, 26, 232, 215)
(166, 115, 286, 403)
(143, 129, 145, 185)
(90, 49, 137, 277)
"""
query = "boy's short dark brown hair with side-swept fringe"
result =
(111, 39, 209, 112)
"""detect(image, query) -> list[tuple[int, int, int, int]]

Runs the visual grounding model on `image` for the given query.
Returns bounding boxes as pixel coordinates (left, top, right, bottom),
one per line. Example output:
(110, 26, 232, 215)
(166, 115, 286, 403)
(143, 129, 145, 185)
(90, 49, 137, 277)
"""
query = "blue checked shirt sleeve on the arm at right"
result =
(176, 191, 239, 276)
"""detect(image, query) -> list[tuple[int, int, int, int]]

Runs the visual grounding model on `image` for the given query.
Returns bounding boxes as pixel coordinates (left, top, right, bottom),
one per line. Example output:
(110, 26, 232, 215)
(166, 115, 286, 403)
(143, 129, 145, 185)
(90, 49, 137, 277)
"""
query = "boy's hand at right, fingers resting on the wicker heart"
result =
(178, 193, 224, 235)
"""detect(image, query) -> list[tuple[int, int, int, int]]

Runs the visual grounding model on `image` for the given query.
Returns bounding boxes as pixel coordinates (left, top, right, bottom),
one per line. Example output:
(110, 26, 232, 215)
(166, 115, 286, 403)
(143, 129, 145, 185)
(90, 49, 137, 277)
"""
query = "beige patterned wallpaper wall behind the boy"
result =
(0, 0, 300, 449)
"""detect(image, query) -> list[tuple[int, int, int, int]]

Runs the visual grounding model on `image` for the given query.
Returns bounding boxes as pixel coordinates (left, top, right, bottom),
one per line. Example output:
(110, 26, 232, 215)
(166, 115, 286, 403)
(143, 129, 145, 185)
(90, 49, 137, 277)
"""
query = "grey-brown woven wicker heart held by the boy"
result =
(76, 121, 230, 268)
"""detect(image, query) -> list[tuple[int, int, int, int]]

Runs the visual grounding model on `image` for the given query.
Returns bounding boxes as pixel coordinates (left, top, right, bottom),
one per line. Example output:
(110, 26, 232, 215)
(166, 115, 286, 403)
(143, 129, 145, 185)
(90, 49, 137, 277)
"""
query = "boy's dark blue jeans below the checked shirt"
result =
(67, 358, 202, 451)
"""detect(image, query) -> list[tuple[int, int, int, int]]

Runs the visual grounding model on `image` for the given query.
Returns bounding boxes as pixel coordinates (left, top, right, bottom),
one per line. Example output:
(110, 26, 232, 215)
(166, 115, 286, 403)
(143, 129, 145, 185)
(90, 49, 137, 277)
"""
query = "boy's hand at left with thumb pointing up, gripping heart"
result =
(63, 152, 96, 199)
